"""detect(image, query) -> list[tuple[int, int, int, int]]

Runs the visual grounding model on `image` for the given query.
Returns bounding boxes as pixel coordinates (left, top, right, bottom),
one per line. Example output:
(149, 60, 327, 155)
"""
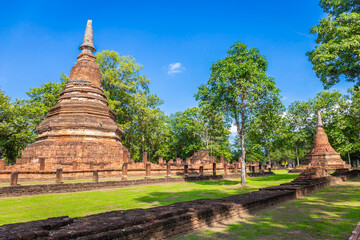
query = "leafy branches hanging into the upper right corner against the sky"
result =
(307, 0, 360, 88)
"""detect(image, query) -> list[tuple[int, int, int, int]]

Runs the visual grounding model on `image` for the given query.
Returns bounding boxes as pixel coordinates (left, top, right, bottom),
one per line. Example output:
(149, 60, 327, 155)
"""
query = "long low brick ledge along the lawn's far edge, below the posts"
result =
(0, 172, 274, 197)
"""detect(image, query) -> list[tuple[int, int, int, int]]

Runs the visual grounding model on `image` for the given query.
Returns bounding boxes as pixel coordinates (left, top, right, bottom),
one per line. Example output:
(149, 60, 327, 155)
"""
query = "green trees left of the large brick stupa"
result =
(0, 74, 67, 163)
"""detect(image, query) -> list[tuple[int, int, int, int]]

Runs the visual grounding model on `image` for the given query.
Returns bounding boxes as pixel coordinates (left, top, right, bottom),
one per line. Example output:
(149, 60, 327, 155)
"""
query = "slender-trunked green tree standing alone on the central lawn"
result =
(196, 42, 278, 185)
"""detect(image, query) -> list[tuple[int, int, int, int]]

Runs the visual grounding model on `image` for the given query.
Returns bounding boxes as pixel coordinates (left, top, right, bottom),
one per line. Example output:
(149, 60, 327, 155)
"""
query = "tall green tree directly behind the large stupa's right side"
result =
(96, 50, 166, 160)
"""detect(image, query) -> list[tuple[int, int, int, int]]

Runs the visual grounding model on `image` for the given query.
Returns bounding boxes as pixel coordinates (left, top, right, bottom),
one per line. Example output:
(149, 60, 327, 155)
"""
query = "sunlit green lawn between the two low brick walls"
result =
(0, 170, 297, 225)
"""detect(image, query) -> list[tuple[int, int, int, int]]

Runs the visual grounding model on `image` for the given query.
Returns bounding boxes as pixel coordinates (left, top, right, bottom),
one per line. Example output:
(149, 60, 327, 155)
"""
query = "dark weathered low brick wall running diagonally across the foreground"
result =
(0, 171, 360, 240)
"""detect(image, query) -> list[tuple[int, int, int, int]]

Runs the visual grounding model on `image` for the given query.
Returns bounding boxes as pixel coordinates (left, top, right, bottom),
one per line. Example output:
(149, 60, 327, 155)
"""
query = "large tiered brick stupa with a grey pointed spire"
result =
(16, 20, 124, 169)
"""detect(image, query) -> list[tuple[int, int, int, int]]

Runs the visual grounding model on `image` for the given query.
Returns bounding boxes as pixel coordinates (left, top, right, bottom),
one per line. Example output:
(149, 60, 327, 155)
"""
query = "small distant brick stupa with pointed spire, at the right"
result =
(302, 111, 348, 170)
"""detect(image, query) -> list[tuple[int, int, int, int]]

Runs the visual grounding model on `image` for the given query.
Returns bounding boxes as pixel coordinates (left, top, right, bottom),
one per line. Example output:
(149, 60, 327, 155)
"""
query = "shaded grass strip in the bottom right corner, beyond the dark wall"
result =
(178, 177, 360, 240)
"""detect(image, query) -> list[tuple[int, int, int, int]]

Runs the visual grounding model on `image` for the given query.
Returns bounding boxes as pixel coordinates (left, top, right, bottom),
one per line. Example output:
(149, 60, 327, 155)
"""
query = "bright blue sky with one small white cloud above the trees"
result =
(0, 0, 352, 117)
